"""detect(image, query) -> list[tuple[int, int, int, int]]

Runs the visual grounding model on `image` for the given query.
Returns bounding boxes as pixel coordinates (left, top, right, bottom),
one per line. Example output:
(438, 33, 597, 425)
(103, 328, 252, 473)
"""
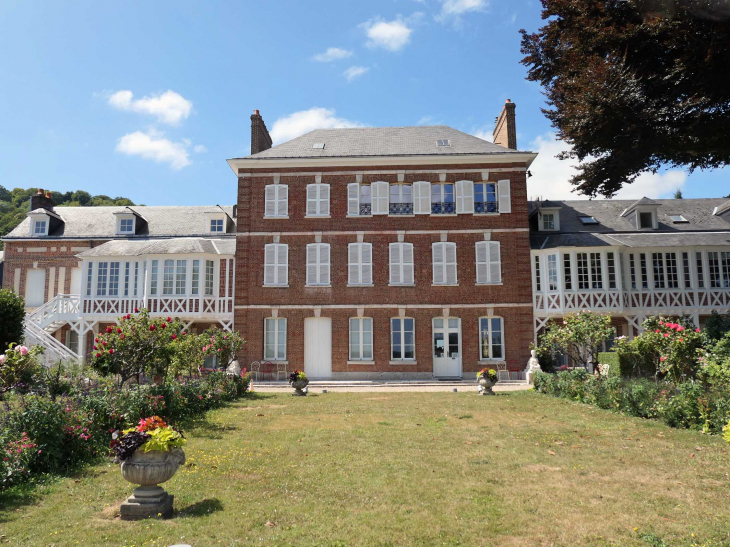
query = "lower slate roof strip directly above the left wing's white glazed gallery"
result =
(77, 237, 236, 258)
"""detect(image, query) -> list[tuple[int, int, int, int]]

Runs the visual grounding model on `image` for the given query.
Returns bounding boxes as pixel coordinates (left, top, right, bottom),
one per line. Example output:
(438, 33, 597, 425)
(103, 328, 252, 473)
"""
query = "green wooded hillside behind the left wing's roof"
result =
(0, 186, 134, 250)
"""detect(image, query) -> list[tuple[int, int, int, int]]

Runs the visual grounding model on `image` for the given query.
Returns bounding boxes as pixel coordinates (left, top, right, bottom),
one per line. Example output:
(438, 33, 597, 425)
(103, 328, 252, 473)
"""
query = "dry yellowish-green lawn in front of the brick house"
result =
(0, 392, 730, 547)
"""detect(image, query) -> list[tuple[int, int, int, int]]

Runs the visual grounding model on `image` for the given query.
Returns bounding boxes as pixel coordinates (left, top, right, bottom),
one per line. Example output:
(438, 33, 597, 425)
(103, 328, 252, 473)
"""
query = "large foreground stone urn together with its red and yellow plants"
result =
(111, 416, 185, 520)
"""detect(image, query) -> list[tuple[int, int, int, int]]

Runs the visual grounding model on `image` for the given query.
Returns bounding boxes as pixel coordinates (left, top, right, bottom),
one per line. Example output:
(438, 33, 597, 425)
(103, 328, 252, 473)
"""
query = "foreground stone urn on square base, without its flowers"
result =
(120, 448, 185, 520)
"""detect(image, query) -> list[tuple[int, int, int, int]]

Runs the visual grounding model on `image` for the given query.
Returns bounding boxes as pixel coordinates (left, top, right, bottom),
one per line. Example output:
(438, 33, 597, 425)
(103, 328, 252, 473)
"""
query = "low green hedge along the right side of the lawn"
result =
(534, 369, 730, 435)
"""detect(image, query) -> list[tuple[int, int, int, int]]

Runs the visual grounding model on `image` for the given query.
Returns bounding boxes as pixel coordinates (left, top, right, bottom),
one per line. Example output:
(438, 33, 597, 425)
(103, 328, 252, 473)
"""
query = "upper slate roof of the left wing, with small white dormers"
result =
(3, 205, 235, 239)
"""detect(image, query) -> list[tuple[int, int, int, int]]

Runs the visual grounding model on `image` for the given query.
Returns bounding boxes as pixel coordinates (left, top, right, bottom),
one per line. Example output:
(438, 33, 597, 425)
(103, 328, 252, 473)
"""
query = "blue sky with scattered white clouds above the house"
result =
(0, 0, 730, 205)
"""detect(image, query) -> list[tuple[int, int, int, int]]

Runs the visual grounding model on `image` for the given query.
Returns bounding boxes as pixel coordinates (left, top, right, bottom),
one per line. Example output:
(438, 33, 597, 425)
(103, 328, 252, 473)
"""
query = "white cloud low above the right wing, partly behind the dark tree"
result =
(527, 133, 687, 200)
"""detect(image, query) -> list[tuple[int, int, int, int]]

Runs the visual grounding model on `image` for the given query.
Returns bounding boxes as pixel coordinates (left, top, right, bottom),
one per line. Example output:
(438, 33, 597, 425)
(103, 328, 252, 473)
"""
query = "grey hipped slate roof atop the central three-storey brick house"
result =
(237, 125, 521, 159)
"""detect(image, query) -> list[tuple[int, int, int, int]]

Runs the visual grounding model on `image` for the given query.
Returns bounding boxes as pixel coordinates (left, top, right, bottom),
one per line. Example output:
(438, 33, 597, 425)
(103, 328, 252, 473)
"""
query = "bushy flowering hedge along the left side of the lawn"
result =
(0, 372, 250, 490)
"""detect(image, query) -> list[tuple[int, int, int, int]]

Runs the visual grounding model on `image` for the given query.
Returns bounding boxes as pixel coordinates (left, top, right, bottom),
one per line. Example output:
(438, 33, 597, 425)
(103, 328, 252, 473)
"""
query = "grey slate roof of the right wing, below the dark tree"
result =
(530, 198, 730, 249)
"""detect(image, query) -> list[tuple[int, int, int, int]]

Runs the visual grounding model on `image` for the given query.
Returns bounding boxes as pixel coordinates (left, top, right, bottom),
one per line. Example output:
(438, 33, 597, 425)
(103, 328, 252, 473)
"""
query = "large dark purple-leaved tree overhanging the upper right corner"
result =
(520, 0, 730, 197)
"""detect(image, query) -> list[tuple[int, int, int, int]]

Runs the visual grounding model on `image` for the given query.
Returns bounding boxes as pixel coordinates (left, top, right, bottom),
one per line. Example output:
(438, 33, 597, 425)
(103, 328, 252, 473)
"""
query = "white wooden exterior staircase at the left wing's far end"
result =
(23, 294, 81, 367)
